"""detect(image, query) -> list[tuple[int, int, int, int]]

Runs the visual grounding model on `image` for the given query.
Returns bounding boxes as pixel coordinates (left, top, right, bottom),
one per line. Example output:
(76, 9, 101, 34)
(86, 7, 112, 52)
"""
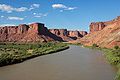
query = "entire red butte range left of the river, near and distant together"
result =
(0, 23, 87, 42)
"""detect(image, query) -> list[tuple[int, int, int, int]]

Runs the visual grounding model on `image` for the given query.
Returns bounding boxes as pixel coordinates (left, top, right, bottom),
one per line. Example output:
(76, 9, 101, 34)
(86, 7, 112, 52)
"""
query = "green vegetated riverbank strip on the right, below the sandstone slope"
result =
(85, 44, 120, 80)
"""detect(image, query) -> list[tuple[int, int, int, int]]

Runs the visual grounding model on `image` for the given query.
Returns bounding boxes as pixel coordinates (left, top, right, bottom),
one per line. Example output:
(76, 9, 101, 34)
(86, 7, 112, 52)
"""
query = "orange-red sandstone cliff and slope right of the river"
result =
(80, 16, 120, 48)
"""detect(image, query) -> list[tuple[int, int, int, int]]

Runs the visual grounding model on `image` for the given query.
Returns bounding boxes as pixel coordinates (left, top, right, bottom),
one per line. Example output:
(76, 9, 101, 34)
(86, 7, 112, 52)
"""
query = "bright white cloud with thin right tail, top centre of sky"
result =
(52, 4, 77, 12)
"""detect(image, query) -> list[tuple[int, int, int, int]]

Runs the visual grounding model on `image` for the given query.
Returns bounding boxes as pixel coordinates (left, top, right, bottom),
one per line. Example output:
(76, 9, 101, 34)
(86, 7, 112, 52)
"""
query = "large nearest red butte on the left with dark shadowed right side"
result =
(0, 23, 63, 42)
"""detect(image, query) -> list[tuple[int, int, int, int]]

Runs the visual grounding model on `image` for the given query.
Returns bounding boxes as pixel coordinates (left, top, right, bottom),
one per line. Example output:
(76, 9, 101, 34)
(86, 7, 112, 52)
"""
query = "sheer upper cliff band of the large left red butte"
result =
(0, 23, 45, 35)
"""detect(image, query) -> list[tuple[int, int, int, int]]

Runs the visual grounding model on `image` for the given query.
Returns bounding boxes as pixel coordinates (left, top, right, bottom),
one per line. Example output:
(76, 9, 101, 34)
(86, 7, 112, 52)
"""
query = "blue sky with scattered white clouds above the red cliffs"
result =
(0, 0, 120, 31)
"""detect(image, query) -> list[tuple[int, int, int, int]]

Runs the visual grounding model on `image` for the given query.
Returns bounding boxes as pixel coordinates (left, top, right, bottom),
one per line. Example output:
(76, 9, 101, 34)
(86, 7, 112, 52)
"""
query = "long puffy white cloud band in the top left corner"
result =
(0, 4, 40, 13)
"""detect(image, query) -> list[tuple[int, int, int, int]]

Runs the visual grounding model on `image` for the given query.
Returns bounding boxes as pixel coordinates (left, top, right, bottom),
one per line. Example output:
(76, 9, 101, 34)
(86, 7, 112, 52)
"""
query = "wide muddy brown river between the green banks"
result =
(0, 46, 116, 80)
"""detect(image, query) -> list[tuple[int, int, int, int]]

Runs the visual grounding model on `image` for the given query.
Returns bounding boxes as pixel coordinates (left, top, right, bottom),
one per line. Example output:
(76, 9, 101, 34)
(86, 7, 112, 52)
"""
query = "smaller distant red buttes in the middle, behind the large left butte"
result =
(49, 29, 87, 41)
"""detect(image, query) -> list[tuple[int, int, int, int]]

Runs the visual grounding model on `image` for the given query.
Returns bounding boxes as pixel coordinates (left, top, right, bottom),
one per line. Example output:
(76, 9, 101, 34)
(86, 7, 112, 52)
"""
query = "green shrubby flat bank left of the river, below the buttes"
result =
(0, 42, 69, 66)
